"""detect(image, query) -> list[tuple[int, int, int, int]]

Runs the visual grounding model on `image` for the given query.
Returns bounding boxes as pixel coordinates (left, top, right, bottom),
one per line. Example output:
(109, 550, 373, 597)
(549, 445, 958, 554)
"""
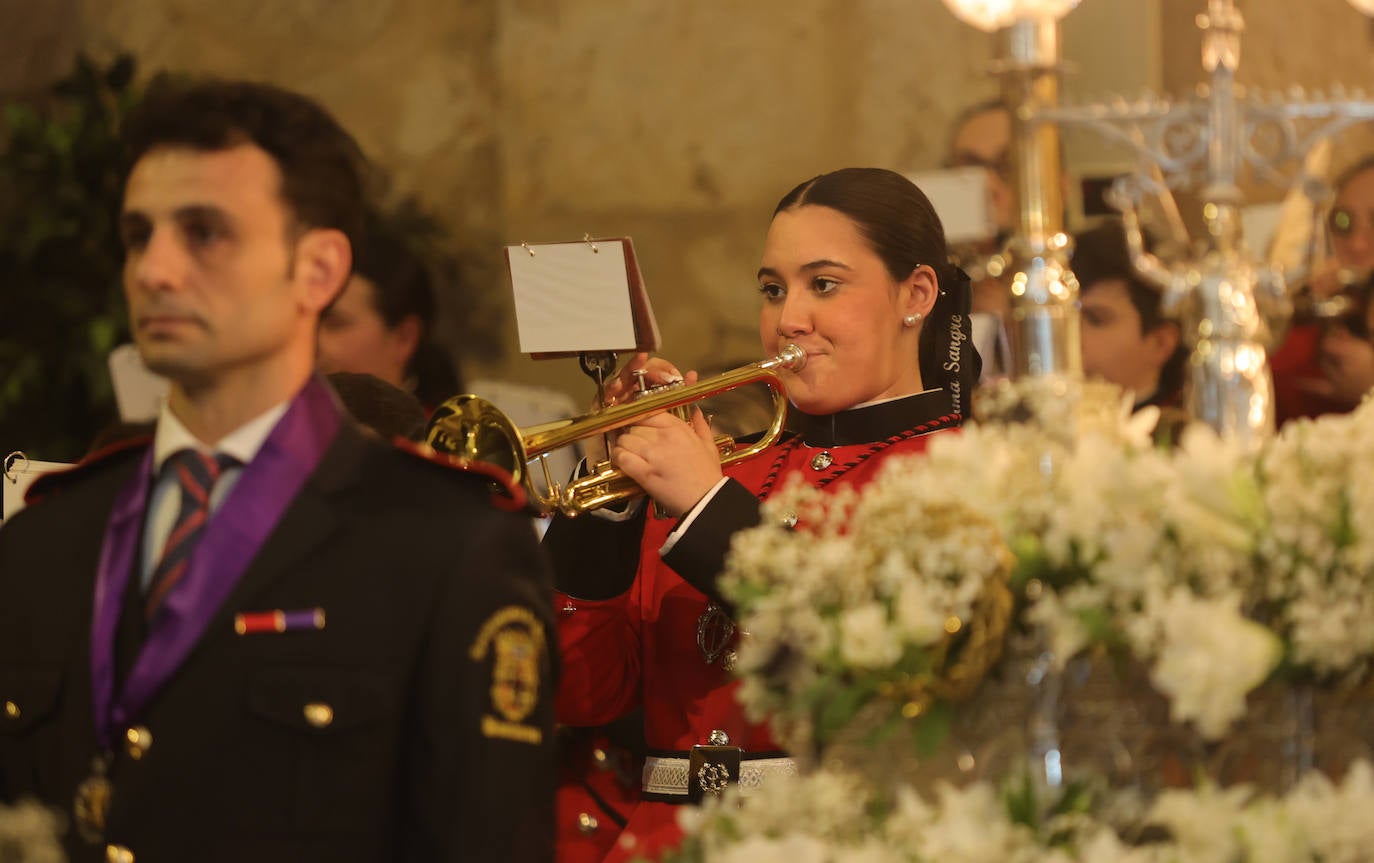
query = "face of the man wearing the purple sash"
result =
(120, 144, 313, 386)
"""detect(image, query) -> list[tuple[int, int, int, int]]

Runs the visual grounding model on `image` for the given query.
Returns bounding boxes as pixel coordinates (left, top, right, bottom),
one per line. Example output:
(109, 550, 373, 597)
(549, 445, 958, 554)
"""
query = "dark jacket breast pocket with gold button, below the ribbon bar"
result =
(247, 668, 404, 834)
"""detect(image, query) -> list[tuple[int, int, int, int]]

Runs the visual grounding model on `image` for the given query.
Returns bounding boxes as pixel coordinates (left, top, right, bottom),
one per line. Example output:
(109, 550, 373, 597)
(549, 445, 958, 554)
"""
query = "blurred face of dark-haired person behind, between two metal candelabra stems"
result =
(1080, 279, 1179, 401)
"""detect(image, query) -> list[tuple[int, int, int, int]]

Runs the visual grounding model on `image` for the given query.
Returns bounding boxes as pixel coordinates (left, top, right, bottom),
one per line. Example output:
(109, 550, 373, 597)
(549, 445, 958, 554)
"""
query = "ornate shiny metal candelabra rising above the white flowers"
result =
(945, 0, 1374, 447)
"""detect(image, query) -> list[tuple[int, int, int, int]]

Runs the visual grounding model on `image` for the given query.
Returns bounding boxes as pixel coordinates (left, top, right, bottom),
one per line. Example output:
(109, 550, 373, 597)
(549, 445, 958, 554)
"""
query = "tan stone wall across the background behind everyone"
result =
(0, 0, 1374, 399)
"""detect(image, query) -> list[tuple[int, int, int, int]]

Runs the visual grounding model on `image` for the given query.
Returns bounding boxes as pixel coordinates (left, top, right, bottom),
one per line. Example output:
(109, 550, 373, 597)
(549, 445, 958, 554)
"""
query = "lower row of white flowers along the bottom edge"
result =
(668, 761, 1374, 863)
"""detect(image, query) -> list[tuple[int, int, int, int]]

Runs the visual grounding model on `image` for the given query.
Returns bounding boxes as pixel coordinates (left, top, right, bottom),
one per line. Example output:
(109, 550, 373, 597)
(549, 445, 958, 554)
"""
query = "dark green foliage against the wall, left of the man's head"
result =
(0, 55, 140, 460)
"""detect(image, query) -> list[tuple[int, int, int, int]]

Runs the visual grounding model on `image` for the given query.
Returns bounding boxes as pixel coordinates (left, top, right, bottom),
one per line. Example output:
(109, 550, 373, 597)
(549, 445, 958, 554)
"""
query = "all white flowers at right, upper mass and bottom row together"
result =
(671, 382, 1374, 863)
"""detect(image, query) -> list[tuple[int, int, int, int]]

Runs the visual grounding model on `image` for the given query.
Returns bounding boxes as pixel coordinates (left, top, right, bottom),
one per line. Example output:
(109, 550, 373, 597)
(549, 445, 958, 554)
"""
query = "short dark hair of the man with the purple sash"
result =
(124, 78, 367, 247)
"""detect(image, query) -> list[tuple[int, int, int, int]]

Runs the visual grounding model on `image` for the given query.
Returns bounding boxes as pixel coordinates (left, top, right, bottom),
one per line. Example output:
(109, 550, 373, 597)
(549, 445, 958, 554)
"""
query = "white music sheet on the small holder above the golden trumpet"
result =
(506, 240, 636, 353)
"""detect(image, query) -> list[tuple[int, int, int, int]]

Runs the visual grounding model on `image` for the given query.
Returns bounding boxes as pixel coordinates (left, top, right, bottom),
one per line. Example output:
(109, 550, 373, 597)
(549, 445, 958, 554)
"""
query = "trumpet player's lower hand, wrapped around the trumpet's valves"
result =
(610, 406, 723, 518)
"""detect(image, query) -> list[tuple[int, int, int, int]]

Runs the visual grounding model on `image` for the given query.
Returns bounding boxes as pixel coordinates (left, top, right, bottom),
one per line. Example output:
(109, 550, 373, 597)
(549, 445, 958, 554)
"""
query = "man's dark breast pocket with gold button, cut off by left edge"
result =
(0, 668, 62, 797)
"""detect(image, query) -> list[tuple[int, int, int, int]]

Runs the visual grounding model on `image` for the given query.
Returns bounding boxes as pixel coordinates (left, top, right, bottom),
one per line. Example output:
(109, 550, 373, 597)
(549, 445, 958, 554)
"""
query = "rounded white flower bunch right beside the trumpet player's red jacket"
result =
(723, 464, 1011, 752)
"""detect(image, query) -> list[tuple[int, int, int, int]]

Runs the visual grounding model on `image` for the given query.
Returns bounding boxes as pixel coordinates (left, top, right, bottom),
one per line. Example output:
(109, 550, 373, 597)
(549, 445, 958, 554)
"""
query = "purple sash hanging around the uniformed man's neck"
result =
(91, 377, 341, 749)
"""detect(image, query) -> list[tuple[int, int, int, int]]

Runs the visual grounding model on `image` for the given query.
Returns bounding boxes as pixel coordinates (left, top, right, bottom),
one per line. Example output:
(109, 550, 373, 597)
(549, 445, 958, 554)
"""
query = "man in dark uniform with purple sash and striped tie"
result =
(0, 82, 555, 863)
